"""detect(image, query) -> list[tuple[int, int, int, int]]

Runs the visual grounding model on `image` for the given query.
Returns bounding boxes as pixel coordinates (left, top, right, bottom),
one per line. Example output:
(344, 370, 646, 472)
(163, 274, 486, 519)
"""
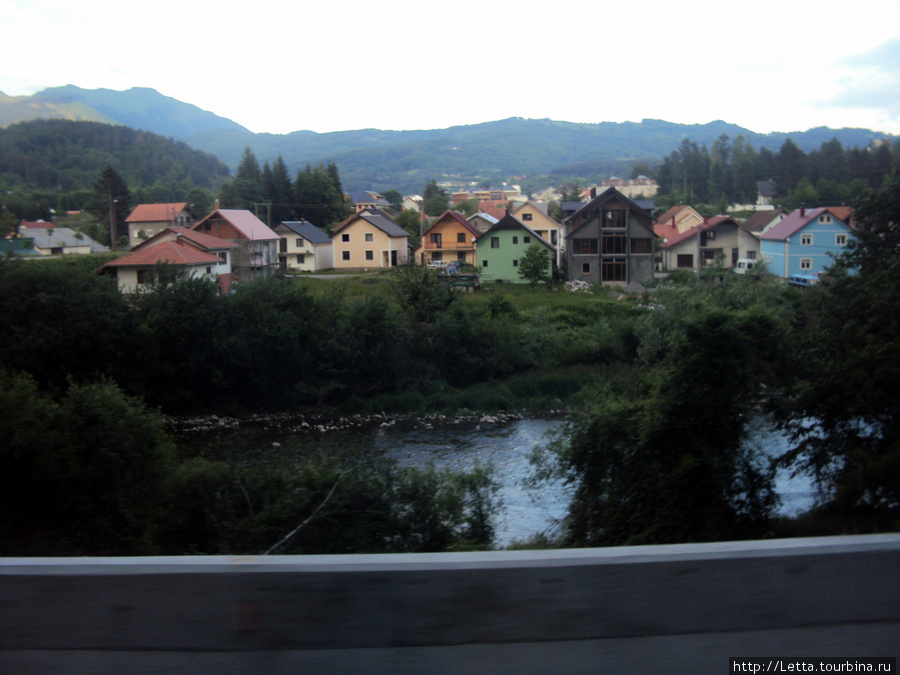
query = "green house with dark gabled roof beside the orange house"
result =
(475, 213, 556, 284)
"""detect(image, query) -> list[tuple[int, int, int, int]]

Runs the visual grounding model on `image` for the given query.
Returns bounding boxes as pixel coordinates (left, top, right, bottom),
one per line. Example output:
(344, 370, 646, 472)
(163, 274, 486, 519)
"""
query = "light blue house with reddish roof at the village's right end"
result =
(759, 208, 853, 279)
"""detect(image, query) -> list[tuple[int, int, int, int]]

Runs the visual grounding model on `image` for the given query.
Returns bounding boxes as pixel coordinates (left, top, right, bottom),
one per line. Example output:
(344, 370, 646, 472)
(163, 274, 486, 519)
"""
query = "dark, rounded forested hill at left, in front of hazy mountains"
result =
(0, 120, 229, 192)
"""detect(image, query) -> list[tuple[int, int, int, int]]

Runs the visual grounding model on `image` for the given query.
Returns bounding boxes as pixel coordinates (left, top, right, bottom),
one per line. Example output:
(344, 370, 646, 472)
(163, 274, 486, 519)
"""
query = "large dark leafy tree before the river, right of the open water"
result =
(551, 280, 787, 546)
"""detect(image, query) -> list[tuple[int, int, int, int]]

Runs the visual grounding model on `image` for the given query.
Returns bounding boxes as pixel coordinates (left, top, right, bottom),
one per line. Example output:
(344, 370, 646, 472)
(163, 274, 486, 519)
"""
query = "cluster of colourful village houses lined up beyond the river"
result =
(8, 176, 854, 292)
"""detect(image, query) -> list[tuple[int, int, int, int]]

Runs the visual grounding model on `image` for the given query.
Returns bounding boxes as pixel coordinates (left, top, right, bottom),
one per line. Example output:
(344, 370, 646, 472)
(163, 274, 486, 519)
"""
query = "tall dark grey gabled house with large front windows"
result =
(564, 188, 656, 285)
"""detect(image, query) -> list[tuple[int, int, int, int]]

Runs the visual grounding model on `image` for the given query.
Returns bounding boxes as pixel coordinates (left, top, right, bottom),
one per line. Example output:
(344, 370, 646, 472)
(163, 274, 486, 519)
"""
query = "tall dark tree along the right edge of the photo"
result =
(782, 171, 900, 513)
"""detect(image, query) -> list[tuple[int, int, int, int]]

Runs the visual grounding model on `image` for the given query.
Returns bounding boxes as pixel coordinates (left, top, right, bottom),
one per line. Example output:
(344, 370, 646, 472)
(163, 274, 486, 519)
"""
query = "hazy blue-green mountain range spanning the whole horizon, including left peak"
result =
(0, 85, 897, 193)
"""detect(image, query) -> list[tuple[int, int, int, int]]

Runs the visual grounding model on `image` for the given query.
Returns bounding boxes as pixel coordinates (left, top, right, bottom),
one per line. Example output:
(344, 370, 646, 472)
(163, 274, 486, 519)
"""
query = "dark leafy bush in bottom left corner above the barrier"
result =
(0, 371, 173, 555)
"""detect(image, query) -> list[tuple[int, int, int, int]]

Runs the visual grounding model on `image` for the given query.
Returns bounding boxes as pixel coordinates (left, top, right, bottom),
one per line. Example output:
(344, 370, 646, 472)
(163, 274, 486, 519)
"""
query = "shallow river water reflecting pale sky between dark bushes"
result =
(172, 418, 815, 548)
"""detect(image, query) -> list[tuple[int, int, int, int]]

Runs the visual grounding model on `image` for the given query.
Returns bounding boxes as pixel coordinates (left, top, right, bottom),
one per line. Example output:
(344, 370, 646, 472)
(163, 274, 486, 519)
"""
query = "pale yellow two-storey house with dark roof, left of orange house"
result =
(331, 211, 409, 269)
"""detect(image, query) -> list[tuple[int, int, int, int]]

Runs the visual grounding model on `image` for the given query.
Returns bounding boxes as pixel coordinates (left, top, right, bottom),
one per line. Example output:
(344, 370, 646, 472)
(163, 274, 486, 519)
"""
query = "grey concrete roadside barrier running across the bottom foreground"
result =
(0, 535, 900, 673)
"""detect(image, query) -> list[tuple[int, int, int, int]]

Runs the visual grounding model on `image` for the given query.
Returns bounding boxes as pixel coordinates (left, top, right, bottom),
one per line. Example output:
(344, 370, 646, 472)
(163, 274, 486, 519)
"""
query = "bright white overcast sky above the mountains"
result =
(0, 0, 900, 134)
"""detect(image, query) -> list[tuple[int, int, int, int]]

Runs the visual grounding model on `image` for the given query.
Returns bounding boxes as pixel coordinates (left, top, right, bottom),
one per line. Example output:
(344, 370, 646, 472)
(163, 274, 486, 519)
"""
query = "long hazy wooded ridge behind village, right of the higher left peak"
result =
(181, 117, 885, 193)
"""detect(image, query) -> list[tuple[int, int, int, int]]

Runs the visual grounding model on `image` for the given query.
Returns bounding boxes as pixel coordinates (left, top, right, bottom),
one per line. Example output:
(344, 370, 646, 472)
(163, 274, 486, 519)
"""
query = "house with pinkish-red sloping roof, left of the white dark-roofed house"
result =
(191, 206, 280, 283)
